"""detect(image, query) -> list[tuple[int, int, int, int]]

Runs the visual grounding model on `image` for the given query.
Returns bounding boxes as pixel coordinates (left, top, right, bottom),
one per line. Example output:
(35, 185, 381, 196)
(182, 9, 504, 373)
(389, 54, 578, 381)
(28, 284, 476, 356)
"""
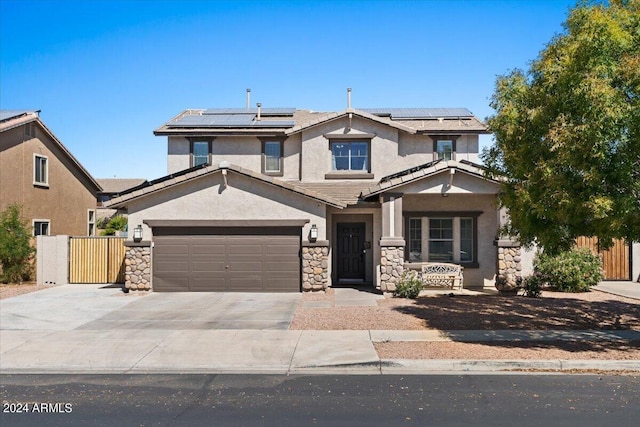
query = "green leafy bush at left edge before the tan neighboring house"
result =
(0, 204, 35, 283)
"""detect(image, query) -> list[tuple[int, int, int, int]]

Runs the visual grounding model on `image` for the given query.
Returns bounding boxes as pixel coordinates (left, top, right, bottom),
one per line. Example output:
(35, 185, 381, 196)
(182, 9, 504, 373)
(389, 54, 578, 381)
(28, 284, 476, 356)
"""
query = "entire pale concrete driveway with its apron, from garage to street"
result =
(0, 285, 380, 374)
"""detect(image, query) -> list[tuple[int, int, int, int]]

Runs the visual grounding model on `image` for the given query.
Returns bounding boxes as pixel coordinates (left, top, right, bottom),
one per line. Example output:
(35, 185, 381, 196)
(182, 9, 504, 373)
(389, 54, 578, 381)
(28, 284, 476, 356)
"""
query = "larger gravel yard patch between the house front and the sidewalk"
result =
(290, 289, 640, 330)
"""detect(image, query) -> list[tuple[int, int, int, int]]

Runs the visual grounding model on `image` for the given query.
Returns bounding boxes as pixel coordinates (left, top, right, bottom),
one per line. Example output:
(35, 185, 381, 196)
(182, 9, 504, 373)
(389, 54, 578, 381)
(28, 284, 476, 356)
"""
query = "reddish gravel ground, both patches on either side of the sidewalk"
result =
(291, 290, 640, 360)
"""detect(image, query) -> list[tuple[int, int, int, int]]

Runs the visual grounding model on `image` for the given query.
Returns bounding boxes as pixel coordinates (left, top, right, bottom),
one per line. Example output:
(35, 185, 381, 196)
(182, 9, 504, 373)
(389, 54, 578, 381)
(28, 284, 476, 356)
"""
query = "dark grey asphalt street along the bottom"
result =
(0, 374, 640, 427)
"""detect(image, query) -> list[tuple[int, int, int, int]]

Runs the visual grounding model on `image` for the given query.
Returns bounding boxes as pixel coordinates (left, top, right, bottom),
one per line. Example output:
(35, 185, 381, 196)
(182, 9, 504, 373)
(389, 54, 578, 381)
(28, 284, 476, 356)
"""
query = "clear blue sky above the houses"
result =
(0, 0, 575, 179)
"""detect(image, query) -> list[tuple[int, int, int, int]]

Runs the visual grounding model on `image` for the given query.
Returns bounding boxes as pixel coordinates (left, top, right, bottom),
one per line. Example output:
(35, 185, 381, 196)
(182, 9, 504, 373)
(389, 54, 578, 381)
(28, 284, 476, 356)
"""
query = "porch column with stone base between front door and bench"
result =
(379, 194, 405, 292)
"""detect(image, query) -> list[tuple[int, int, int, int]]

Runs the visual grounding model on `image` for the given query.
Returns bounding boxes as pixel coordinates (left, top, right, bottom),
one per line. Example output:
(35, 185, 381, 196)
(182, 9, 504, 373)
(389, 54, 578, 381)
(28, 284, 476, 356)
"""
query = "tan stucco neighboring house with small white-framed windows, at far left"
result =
(0, 110, 101, 236)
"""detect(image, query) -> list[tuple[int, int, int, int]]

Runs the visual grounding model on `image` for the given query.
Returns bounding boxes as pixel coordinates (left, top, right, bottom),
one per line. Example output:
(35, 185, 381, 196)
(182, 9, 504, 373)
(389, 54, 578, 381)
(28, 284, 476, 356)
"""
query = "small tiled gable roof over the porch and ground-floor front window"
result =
(361, 160, 497, 200)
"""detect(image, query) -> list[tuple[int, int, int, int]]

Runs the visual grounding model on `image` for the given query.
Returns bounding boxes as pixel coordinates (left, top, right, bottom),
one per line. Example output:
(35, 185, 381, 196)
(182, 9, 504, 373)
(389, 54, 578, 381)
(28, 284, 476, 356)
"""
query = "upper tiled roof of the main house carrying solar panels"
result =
(154, 108, 488, 136)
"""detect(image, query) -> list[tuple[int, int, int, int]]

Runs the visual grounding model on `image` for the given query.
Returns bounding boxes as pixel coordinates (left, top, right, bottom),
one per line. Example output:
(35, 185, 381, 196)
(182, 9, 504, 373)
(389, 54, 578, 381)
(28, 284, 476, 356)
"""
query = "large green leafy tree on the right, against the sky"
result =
(482, 0, 640, 253)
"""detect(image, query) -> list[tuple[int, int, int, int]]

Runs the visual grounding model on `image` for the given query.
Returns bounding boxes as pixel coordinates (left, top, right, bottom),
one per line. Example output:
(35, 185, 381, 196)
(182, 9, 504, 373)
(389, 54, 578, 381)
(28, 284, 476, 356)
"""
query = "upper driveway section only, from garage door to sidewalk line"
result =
(0, 285, 300, 331)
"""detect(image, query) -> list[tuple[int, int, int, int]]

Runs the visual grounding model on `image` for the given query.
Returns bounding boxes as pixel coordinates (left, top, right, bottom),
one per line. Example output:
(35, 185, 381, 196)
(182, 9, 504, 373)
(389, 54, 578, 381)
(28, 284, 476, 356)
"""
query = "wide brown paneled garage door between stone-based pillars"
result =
(153, 227, 301, 292)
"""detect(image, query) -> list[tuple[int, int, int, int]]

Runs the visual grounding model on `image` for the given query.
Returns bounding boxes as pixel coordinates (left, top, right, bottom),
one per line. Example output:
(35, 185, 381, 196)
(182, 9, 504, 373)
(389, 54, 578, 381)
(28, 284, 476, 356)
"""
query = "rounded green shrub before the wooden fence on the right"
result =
(534, 248, 604, 292)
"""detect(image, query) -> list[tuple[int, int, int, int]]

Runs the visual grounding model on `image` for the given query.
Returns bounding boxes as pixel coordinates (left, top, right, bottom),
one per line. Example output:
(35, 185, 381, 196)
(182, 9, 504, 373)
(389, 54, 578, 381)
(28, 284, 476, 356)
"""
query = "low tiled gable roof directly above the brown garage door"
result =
(103, 164, 347, 208)
